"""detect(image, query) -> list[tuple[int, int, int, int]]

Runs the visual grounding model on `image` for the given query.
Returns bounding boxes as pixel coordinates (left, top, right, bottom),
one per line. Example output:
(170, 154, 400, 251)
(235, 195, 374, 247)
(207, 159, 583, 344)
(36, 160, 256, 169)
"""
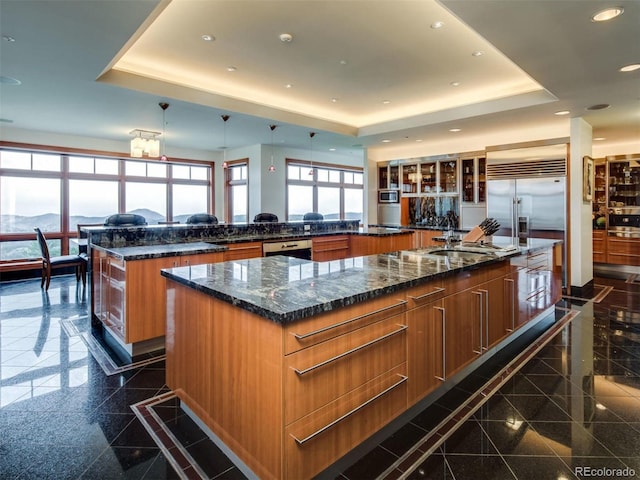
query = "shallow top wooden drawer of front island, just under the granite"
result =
(284, 293, 407, 355)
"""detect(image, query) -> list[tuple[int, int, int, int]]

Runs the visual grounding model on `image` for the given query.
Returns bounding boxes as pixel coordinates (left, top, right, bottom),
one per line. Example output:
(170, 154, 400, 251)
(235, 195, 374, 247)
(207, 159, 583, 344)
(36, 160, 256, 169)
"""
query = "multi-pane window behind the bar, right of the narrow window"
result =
(287, 160, 364, 221)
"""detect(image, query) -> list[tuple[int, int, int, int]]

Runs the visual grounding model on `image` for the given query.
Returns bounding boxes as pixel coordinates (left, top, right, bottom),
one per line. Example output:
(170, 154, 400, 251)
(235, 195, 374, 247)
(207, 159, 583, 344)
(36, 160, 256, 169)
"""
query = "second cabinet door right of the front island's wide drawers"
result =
(443, 289, 483, 378)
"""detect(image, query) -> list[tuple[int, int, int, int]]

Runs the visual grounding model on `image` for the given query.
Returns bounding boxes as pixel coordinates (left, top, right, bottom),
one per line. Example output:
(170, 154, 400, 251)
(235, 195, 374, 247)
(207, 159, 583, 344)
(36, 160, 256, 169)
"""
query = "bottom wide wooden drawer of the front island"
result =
(284, 365, 407, 479)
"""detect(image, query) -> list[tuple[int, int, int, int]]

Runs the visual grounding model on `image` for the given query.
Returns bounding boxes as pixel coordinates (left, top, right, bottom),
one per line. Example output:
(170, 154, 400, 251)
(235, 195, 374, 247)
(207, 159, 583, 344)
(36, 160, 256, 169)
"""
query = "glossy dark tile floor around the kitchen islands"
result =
(0, 276, 640, 480)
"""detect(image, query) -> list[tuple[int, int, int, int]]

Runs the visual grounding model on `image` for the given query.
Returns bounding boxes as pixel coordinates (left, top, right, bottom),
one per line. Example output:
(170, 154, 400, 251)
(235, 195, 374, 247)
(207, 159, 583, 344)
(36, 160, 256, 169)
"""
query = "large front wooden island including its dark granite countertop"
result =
(162, 239, 561, 480)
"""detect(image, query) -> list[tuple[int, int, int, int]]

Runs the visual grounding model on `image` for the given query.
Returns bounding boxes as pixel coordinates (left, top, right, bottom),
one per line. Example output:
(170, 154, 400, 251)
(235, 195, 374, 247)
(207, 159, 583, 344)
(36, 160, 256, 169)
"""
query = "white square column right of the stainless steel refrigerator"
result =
(569, 118, 593, 287)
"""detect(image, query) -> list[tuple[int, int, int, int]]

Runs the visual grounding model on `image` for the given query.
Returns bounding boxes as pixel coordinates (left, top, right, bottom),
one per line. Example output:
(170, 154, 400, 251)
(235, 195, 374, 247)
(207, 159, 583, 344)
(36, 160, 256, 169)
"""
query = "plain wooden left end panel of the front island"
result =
(165, 280, 283, 480)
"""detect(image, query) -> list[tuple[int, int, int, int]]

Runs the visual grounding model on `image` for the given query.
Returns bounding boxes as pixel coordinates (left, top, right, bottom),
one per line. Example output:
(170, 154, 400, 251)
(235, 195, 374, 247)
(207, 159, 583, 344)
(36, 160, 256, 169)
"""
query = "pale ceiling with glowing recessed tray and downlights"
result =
(0, 0, 640, 158)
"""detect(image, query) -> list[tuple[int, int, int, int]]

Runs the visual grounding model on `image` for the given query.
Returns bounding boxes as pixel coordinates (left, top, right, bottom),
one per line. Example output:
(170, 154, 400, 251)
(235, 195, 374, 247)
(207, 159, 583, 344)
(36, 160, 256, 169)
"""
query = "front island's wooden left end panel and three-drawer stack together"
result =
(166, 280, 408, 480)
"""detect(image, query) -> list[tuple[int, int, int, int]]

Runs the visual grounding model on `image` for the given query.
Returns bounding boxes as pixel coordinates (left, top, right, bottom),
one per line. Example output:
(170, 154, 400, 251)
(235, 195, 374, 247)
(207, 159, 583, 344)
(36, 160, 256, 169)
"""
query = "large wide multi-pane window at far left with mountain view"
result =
(0, 148, 213, 261)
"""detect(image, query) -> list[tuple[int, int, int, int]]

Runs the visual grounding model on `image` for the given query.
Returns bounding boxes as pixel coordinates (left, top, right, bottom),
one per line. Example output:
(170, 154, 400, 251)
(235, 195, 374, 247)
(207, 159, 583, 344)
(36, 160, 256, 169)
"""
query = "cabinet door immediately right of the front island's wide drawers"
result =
(407, 300, 446, 405)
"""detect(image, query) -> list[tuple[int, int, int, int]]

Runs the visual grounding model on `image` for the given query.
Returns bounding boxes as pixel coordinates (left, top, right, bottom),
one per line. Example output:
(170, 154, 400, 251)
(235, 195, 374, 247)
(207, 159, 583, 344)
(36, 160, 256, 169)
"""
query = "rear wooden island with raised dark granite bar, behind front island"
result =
(84, 220, 413, 361)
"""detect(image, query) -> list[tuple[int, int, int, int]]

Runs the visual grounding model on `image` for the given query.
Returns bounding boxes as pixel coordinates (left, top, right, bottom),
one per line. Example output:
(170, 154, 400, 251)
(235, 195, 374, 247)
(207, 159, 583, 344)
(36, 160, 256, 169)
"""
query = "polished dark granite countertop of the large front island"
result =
(161, 237, 558, 324)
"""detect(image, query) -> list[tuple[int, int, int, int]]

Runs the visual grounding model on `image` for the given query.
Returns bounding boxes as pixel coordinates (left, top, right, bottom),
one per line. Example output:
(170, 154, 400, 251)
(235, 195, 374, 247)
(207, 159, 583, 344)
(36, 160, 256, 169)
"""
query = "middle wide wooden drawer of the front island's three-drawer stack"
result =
(284, 313, 407, 425)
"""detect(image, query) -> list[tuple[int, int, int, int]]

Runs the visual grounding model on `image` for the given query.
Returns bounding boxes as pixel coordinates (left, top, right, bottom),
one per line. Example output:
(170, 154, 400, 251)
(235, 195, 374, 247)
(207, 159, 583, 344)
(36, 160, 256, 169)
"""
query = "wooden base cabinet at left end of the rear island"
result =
(93, 249, 222, 344)
